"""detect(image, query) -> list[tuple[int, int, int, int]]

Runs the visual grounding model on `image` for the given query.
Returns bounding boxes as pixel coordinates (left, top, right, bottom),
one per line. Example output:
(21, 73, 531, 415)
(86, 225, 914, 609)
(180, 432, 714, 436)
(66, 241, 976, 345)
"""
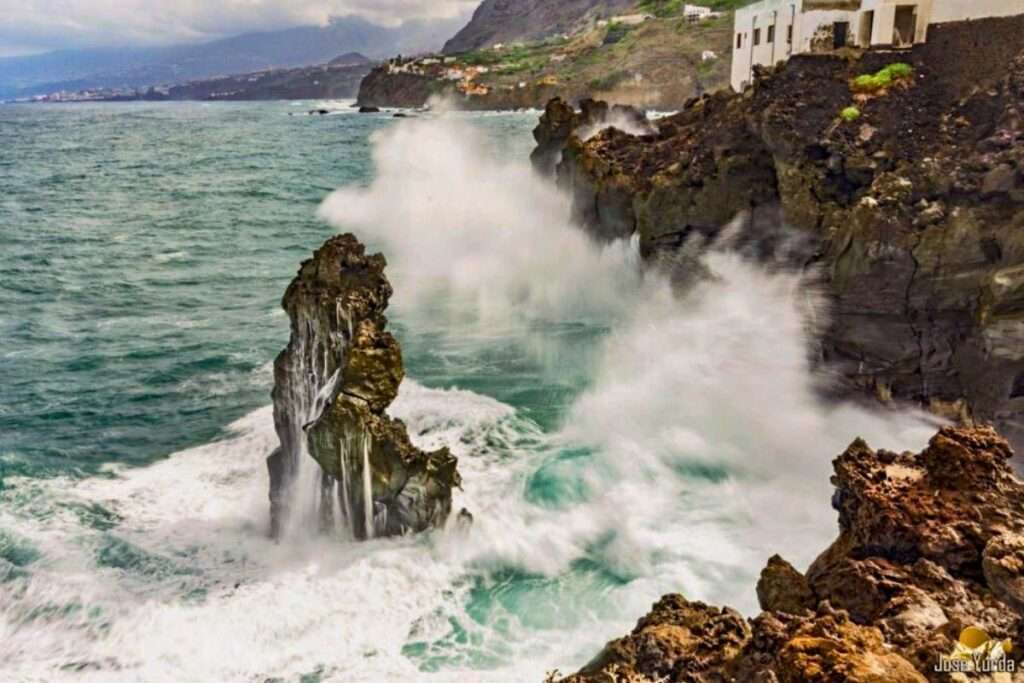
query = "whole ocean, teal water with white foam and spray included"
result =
(0, 102, 934, 683)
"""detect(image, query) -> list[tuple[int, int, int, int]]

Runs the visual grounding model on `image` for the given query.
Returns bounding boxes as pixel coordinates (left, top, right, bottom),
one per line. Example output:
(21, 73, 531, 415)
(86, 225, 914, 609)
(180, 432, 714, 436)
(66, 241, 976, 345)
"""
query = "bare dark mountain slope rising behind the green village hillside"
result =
(444, 0, 637, 54)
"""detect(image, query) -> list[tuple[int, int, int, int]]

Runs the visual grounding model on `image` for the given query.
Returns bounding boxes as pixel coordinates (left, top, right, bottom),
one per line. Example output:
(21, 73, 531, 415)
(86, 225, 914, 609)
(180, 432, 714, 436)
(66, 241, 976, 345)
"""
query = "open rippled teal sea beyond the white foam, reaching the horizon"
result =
(0, 103, 550, 475)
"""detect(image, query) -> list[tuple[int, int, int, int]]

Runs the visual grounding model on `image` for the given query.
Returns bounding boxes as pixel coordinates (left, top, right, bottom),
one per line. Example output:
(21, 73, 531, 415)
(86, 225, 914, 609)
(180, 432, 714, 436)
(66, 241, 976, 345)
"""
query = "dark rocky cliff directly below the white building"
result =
(538, 17, 1024, 443)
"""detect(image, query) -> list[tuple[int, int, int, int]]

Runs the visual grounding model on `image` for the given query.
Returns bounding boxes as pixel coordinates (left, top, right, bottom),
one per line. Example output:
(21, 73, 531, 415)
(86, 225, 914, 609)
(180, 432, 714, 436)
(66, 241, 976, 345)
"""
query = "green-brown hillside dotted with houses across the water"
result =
(359, 0, 735, 110)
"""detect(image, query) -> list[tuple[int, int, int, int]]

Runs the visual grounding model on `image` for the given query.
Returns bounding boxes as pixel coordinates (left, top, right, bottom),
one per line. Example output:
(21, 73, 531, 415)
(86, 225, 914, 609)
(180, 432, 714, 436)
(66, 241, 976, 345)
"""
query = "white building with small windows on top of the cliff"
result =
(732, 0, 1024, 91)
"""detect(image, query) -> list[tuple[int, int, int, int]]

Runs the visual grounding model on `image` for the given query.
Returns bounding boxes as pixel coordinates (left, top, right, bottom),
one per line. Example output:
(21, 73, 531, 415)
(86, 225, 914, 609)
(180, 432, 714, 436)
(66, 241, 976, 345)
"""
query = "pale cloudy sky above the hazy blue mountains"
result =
(0, 0, 479, 56)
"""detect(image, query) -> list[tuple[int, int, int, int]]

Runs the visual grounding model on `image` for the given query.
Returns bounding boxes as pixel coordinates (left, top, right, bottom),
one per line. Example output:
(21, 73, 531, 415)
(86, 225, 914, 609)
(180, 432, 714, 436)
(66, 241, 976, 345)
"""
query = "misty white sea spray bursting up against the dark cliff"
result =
(322, 111, 935, 613)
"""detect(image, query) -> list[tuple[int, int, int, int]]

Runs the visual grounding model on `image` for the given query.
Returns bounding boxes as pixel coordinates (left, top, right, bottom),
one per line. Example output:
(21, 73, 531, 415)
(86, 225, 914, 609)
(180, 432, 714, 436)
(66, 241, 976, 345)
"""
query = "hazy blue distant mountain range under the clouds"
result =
(0, 17, 465, 97)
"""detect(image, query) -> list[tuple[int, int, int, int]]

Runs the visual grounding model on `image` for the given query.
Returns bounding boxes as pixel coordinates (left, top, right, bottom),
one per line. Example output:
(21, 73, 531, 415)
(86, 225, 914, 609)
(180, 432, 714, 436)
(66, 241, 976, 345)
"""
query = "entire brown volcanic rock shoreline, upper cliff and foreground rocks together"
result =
(532, 12, 1024, 683)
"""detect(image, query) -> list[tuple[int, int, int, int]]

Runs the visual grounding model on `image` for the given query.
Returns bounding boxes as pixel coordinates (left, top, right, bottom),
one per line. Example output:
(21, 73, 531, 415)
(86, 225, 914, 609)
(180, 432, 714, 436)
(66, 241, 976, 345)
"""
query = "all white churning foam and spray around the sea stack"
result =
(0, 109, 932, 683)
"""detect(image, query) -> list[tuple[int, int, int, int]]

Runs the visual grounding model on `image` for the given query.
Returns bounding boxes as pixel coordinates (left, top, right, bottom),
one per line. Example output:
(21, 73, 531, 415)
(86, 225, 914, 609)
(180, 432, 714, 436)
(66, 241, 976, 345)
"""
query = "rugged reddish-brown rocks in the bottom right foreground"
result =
(563, 428, 1024, 683)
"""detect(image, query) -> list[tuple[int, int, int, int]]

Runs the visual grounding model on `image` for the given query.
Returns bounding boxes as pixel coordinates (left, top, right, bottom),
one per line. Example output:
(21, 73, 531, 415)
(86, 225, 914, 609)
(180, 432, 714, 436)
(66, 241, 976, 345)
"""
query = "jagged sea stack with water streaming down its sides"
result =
(267, 234, 460, 540)
